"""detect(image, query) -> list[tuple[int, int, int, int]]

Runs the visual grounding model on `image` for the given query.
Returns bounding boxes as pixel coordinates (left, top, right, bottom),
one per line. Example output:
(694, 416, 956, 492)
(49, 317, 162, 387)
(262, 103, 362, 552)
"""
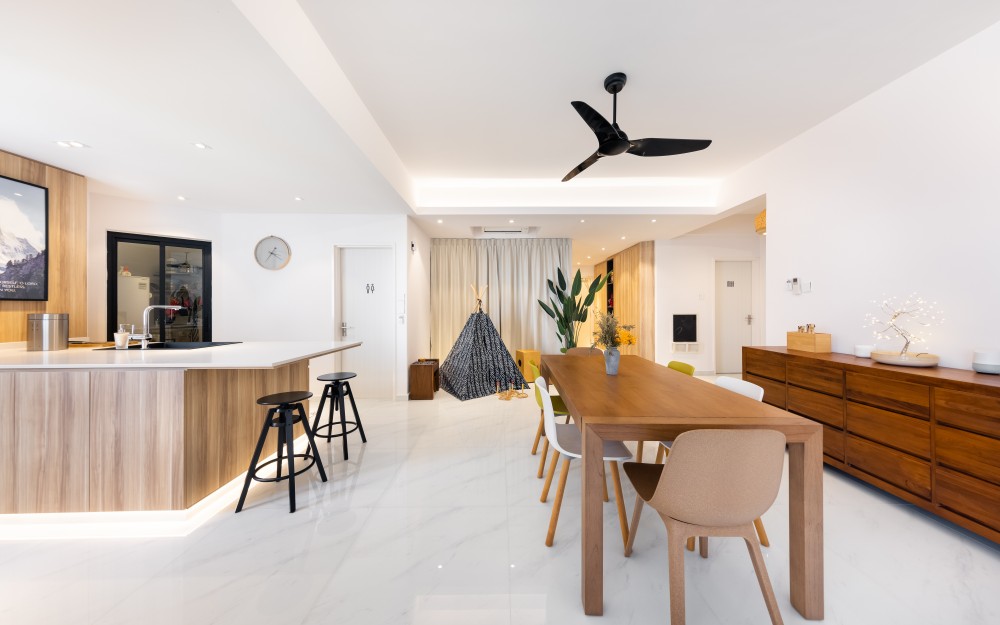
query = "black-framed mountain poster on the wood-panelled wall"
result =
(0, 176, 49, 301)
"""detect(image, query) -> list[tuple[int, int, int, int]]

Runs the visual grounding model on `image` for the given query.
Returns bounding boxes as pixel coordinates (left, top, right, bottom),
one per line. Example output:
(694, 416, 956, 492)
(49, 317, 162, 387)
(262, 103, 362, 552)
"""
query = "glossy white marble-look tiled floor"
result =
(0, 393, 1000, 625)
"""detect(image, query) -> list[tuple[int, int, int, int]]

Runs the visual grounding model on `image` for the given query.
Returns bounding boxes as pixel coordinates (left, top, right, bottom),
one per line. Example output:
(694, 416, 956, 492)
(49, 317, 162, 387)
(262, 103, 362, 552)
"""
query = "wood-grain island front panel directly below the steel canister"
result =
(14, 371, 90, 513)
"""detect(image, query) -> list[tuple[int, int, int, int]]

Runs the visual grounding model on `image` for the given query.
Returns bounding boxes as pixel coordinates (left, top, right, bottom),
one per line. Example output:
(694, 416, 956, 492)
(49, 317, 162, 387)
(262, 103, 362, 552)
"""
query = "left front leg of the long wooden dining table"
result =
(580, 424, 604, 616)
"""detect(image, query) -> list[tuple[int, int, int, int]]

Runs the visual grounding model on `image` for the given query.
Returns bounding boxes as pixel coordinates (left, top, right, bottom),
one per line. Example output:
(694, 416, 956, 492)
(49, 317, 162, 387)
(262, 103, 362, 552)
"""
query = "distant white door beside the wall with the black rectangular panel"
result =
(715, 260, 754, 373)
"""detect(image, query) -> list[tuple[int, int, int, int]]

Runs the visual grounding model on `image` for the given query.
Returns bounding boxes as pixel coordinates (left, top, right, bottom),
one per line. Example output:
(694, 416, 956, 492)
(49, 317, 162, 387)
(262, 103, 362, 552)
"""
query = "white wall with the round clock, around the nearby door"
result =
(212, 214, 410, 397)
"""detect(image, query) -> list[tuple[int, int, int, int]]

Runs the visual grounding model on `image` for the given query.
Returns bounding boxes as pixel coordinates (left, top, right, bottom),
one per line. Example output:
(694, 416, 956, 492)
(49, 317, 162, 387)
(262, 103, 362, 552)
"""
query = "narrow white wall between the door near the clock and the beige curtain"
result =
(406, 218, 431, 362)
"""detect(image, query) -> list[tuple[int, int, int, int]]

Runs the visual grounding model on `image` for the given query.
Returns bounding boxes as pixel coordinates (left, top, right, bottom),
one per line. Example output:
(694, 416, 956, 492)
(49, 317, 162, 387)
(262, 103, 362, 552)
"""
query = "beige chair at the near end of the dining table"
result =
(625, 430, 785, 625)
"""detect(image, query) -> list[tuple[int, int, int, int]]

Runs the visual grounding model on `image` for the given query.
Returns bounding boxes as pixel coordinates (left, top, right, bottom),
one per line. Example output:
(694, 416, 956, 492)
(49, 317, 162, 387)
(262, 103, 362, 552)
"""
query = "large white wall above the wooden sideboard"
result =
(720, 20, 1000, 368)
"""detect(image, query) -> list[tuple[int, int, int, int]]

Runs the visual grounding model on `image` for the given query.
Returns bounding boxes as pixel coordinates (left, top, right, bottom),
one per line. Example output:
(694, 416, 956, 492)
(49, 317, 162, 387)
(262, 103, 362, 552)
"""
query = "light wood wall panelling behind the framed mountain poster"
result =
(0, 151, 87, 342)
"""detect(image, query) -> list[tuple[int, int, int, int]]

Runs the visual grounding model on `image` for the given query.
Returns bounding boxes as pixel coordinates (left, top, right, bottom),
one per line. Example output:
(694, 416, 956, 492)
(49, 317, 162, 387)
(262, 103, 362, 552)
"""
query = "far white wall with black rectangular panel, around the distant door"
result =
(652, 232, 770, 373)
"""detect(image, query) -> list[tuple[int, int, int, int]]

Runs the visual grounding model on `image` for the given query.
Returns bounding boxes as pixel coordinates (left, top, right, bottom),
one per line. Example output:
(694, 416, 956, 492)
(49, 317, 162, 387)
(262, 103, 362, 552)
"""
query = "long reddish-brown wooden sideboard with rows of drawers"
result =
(743, 347, 1000, 542)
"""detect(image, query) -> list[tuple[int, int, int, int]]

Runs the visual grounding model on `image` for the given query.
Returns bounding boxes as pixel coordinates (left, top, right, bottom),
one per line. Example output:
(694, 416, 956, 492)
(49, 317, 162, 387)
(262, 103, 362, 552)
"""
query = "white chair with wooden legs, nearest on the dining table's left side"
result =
(535, 378, 632, 547)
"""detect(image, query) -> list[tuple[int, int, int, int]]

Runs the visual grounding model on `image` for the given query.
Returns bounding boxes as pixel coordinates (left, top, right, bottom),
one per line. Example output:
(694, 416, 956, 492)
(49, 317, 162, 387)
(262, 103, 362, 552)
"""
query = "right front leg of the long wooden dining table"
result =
(788, 431, 824, 620)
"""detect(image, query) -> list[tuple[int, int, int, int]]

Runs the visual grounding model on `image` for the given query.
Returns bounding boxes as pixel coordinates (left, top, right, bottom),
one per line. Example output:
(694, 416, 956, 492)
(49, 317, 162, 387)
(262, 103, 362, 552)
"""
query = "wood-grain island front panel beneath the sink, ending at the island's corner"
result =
(90, 371, 184, 511)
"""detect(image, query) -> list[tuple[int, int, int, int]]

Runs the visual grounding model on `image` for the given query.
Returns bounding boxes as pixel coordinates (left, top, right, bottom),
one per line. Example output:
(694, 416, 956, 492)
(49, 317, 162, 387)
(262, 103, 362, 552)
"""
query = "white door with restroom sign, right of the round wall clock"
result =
(335, 247, 396, 399)
